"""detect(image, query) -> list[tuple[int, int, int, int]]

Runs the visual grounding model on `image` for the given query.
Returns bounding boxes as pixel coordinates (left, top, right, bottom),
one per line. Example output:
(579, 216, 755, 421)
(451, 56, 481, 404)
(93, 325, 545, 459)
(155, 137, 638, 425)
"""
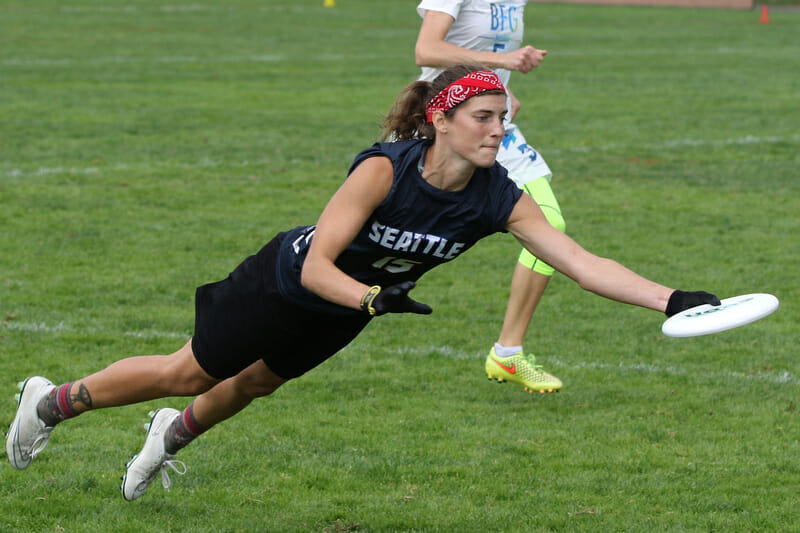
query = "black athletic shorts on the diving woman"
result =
(192, 233, 370, 379)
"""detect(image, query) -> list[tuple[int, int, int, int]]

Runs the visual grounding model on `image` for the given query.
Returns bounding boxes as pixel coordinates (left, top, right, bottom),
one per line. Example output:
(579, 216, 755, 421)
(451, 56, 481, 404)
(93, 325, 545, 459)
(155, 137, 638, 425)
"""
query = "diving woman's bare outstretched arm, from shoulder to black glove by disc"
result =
(506, 194, 675, 312)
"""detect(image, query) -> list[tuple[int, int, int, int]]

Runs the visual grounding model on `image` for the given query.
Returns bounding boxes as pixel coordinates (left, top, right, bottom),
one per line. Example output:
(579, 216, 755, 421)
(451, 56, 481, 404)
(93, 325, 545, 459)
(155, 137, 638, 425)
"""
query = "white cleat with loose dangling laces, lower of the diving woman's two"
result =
(120, 409, 186, 502)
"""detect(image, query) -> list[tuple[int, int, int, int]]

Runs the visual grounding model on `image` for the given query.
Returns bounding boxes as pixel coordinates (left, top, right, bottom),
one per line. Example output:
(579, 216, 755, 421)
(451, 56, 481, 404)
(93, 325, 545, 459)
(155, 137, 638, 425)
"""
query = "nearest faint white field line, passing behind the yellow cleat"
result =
(0, 320, 800, 385)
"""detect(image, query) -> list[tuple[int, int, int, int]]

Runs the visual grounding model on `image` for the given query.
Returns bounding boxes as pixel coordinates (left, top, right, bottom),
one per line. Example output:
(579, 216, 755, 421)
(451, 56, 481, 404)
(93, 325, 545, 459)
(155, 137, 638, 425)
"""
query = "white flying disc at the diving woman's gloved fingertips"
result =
(661, 293, 778, 337)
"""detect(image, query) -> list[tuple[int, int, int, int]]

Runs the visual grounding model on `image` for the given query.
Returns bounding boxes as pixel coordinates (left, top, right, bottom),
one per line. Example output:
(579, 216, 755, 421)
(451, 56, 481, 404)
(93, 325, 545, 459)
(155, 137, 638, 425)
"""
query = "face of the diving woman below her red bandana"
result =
(447, 94, 507, 168)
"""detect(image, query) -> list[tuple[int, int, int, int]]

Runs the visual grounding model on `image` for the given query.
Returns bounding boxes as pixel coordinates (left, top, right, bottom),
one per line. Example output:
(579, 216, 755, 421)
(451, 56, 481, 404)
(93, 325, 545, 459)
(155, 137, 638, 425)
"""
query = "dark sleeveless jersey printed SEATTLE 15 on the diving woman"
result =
(277, 140, 522, 314)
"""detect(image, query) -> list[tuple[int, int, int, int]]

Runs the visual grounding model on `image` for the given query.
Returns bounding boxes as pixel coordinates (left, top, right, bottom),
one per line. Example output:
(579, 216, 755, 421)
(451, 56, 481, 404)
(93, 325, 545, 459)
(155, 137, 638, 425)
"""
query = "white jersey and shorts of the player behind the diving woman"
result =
(417, 0, 551, 187)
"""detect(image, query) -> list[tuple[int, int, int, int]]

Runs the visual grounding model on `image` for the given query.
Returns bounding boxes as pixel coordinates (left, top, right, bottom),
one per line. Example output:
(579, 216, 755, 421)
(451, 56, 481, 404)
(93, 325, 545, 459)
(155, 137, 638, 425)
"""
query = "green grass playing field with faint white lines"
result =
(0, 0, 800, 532)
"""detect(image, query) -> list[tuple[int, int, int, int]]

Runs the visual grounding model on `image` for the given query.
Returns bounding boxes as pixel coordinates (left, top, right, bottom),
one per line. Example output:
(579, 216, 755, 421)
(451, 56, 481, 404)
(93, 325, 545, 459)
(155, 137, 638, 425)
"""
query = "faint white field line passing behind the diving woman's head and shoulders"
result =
(0, 134, 800, 182)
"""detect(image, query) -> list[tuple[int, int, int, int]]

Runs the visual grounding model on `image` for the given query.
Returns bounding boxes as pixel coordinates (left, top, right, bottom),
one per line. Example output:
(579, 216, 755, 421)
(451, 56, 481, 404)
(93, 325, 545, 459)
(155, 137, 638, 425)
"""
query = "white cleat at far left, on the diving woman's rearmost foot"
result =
(6, 376, 56, 470)
